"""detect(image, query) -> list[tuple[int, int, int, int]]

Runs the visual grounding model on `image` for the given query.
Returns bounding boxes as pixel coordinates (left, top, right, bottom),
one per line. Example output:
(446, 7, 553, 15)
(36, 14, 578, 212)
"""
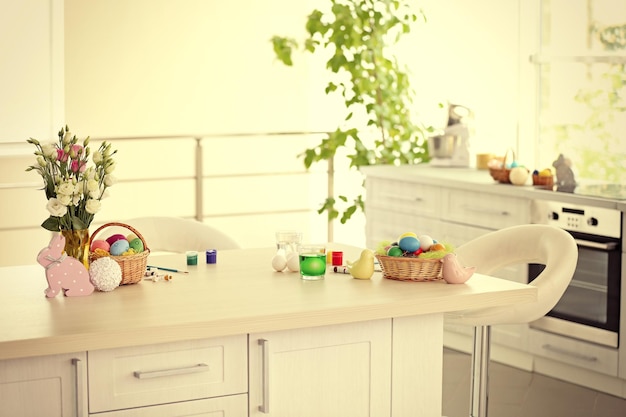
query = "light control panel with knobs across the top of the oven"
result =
(531, 200, 622, 239)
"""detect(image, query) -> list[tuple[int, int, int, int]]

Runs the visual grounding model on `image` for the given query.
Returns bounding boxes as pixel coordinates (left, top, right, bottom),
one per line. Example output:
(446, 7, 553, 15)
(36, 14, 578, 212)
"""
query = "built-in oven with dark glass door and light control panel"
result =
(528, 200, 622, 348)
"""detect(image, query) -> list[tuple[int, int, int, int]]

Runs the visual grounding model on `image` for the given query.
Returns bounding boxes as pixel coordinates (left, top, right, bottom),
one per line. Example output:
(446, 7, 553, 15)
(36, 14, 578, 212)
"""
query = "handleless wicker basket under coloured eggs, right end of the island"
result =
(376, 255, 442, 281)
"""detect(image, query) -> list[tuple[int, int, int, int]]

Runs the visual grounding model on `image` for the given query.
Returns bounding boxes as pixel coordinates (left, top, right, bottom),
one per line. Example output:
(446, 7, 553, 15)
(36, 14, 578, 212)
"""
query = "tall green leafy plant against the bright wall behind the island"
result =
(272, 0, 431, 223)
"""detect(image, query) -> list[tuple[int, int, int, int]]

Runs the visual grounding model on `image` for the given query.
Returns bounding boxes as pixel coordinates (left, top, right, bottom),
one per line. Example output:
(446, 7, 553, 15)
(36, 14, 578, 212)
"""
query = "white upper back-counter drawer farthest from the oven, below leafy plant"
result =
(366, 178, 441, 217)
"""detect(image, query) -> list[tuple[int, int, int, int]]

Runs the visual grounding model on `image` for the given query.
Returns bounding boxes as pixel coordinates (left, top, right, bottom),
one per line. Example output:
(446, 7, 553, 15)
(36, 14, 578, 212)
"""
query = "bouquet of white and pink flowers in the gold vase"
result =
(26, 126, 117, 232)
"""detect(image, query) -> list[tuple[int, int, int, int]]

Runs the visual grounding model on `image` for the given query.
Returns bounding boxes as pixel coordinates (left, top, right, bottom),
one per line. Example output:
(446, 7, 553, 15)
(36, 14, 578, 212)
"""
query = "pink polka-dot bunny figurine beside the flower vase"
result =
(37, 234, 94, 298)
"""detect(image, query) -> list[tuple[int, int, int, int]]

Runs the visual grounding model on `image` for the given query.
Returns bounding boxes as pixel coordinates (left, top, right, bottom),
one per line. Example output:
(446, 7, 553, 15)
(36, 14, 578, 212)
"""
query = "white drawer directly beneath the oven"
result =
(529, 329, 618, 376)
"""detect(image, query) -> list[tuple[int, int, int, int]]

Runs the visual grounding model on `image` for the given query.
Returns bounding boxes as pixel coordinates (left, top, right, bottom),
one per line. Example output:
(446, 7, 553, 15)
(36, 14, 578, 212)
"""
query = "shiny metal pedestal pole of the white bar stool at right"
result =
(470, 326, 491, 417)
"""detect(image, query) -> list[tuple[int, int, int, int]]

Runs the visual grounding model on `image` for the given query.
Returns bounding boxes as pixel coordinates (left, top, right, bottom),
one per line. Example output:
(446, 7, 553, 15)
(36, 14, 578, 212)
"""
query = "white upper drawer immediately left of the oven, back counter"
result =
(442, 189, 530, 230)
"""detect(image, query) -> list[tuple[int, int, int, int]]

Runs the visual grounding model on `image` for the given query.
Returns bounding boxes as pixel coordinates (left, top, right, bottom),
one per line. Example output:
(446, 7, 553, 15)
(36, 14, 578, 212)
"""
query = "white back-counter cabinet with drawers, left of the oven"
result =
(365, 167, 530, 351)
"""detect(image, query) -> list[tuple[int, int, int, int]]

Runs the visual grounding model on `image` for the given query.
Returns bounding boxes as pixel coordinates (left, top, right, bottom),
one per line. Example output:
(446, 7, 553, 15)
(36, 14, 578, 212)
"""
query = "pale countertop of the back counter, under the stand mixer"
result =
(361, 164, 626, 211)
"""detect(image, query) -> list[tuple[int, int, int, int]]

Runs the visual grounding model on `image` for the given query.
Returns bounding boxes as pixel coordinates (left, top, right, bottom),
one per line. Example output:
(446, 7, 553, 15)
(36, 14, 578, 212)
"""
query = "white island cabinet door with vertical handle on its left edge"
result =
(249, 320, 391, 417)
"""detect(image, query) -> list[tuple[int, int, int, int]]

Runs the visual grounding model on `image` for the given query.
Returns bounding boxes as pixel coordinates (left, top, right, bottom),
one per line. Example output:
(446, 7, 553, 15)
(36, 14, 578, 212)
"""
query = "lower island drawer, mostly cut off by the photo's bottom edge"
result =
(90, 394, 248, 417)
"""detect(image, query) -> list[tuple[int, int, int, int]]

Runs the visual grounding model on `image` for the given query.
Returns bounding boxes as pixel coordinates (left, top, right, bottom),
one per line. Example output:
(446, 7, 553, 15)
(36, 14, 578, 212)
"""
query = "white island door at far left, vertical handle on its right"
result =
(0, 353, 87, 417)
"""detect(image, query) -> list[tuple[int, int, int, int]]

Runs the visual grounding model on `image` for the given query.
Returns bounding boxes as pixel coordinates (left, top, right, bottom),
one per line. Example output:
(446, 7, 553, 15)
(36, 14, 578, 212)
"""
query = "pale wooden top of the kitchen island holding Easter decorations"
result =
(0, 244, 537, 359)
